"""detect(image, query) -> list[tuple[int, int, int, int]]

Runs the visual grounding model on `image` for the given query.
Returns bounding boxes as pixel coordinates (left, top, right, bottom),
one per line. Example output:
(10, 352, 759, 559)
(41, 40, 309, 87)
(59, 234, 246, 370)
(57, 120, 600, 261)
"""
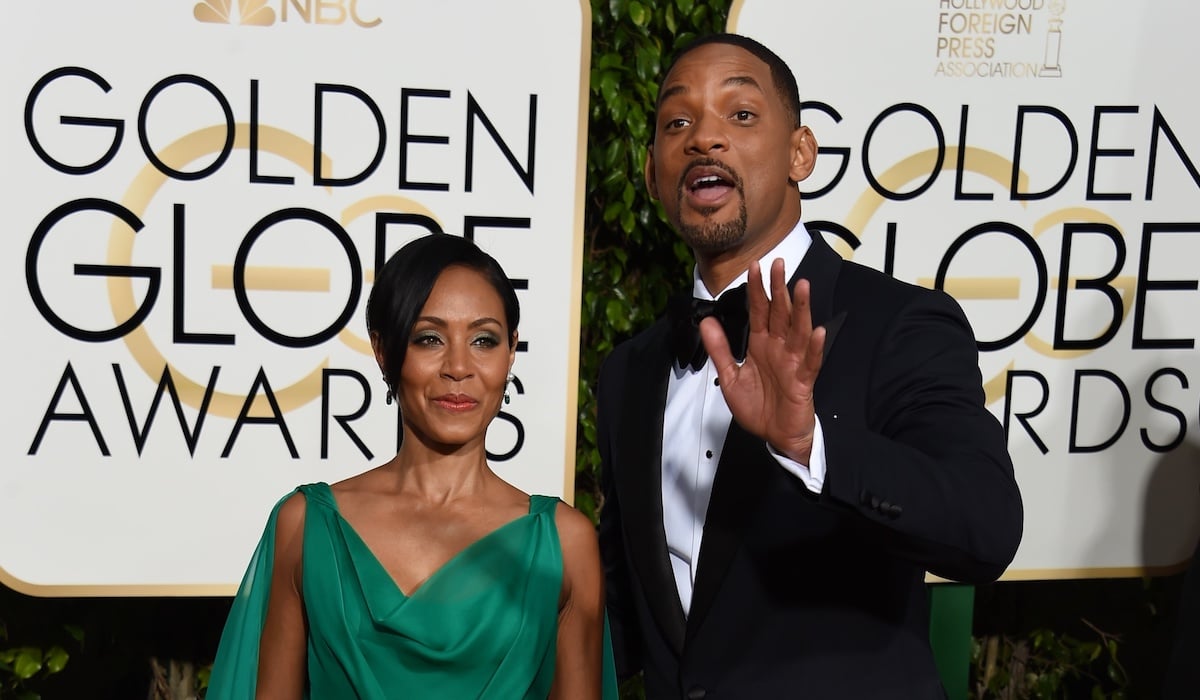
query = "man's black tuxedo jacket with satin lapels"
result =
(599, 234, 1022, 700)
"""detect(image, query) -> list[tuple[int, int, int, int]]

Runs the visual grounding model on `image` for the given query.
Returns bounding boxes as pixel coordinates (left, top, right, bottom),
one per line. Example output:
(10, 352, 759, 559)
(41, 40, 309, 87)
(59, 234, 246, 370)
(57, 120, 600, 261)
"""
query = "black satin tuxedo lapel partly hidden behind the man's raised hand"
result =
(686, 233, 846, 638)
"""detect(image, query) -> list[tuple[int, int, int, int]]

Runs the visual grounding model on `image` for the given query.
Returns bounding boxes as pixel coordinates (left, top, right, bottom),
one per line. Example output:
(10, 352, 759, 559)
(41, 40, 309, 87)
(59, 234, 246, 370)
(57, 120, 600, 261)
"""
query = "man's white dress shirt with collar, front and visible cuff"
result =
(661, 222, 826, 615)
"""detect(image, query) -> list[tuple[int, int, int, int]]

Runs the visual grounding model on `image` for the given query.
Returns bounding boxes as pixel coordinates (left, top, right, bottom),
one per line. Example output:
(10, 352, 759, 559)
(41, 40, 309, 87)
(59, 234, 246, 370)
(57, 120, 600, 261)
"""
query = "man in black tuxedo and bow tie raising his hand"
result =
(599, 35, 1021, 700)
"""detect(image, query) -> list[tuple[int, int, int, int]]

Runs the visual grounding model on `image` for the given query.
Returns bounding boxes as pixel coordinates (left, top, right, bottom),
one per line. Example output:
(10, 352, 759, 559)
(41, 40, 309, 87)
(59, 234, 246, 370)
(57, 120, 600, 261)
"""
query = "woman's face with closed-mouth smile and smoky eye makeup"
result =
(396, 267, 516, 450)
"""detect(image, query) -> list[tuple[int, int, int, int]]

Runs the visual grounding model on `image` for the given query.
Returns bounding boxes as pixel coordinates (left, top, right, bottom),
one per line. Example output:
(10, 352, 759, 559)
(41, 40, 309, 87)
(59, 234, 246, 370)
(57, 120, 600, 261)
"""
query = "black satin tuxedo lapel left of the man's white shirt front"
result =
(613, 322, 684, 653)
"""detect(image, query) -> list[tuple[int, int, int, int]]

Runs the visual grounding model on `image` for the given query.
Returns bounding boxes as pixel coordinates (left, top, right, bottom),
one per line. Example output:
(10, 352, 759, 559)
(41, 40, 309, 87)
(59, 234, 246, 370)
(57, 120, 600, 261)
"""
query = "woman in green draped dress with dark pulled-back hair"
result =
(208, 234, 616, 700)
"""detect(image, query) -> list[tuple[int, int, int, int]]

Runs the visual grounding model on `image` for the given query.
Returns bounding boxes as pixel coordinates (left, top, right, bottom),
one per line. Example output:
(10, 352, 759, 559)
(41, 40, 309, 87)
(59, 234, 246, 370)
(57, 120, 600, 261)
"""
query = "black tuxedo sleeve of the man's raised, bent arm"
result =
(817, 291, 1022, 582)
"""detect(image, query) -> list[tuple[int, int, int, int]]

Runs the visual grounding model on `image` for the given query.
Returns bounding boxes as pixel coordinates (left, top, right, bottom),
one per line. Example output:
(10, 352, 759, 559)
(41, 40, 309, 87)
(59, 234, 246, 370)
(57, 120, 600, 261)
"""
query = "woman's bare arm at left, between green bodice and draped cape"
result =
(256, 493, 308, 700)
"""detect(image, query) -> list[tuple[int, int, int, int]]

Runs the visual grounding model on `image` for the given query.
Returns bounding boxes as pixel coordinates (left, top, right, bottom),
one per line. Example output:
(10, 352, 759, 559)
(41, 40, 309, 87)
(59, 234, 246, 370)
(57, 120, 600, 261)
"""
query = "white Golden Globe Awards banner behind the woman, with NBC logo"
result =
(0, 0, 590, 596)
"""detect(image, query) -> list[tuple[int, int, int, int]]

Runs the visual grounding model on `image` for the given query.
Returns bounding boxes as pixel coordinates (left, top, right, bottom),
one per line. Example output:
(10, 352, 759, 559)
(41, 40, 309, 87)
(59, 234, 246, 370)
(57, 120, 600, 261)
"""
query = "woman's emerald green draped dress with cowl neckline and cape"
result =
(206, 484, 617, 700)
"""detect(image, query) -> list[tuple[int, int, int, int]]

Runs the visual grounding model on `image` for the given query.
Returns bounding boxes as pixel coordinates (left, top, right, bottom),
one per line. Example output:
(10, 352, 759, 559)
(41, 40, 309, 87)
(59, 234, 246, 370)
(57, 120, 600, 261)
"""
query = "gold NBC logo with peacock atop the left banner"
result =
(192, 0, 383, 29)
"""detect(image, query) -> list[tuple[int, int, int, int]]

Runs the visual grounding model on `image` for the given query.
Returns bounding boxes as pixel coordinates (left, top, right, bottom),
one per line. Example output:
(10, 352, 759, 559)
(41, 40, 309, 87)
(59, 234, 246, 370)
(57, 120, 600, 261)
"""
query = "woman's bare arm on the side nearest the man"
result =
(550, 503, 604, 700)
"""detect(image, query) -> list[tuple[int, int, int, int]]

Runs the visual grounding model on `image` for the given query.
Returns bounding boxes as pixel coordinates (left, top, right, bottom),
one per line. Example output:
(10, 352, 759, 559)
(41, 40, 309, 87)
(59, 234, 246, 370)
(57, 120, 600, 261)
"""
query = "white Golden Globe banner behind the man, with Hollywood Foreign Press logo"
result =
(728, 0, 1200, 579)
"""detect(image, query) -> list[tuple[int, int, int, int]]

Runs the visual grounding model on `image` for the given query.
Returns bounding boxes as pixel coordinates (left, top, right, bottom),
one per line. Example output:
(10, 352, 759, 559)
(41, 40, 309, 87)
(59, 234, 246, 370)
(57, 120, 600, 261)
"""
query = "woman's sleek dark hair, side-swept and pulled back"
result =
(367, 233, 521, 389)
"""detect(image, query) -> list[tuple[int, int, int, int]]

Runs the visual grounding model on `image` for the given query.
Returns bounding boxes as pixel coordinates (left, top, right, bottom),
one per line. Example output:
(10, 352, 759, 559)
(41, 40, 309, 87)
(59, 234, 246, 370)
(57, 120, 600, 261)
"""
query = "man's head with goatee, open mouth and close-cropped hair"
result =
(646, 43, 816, 256)
